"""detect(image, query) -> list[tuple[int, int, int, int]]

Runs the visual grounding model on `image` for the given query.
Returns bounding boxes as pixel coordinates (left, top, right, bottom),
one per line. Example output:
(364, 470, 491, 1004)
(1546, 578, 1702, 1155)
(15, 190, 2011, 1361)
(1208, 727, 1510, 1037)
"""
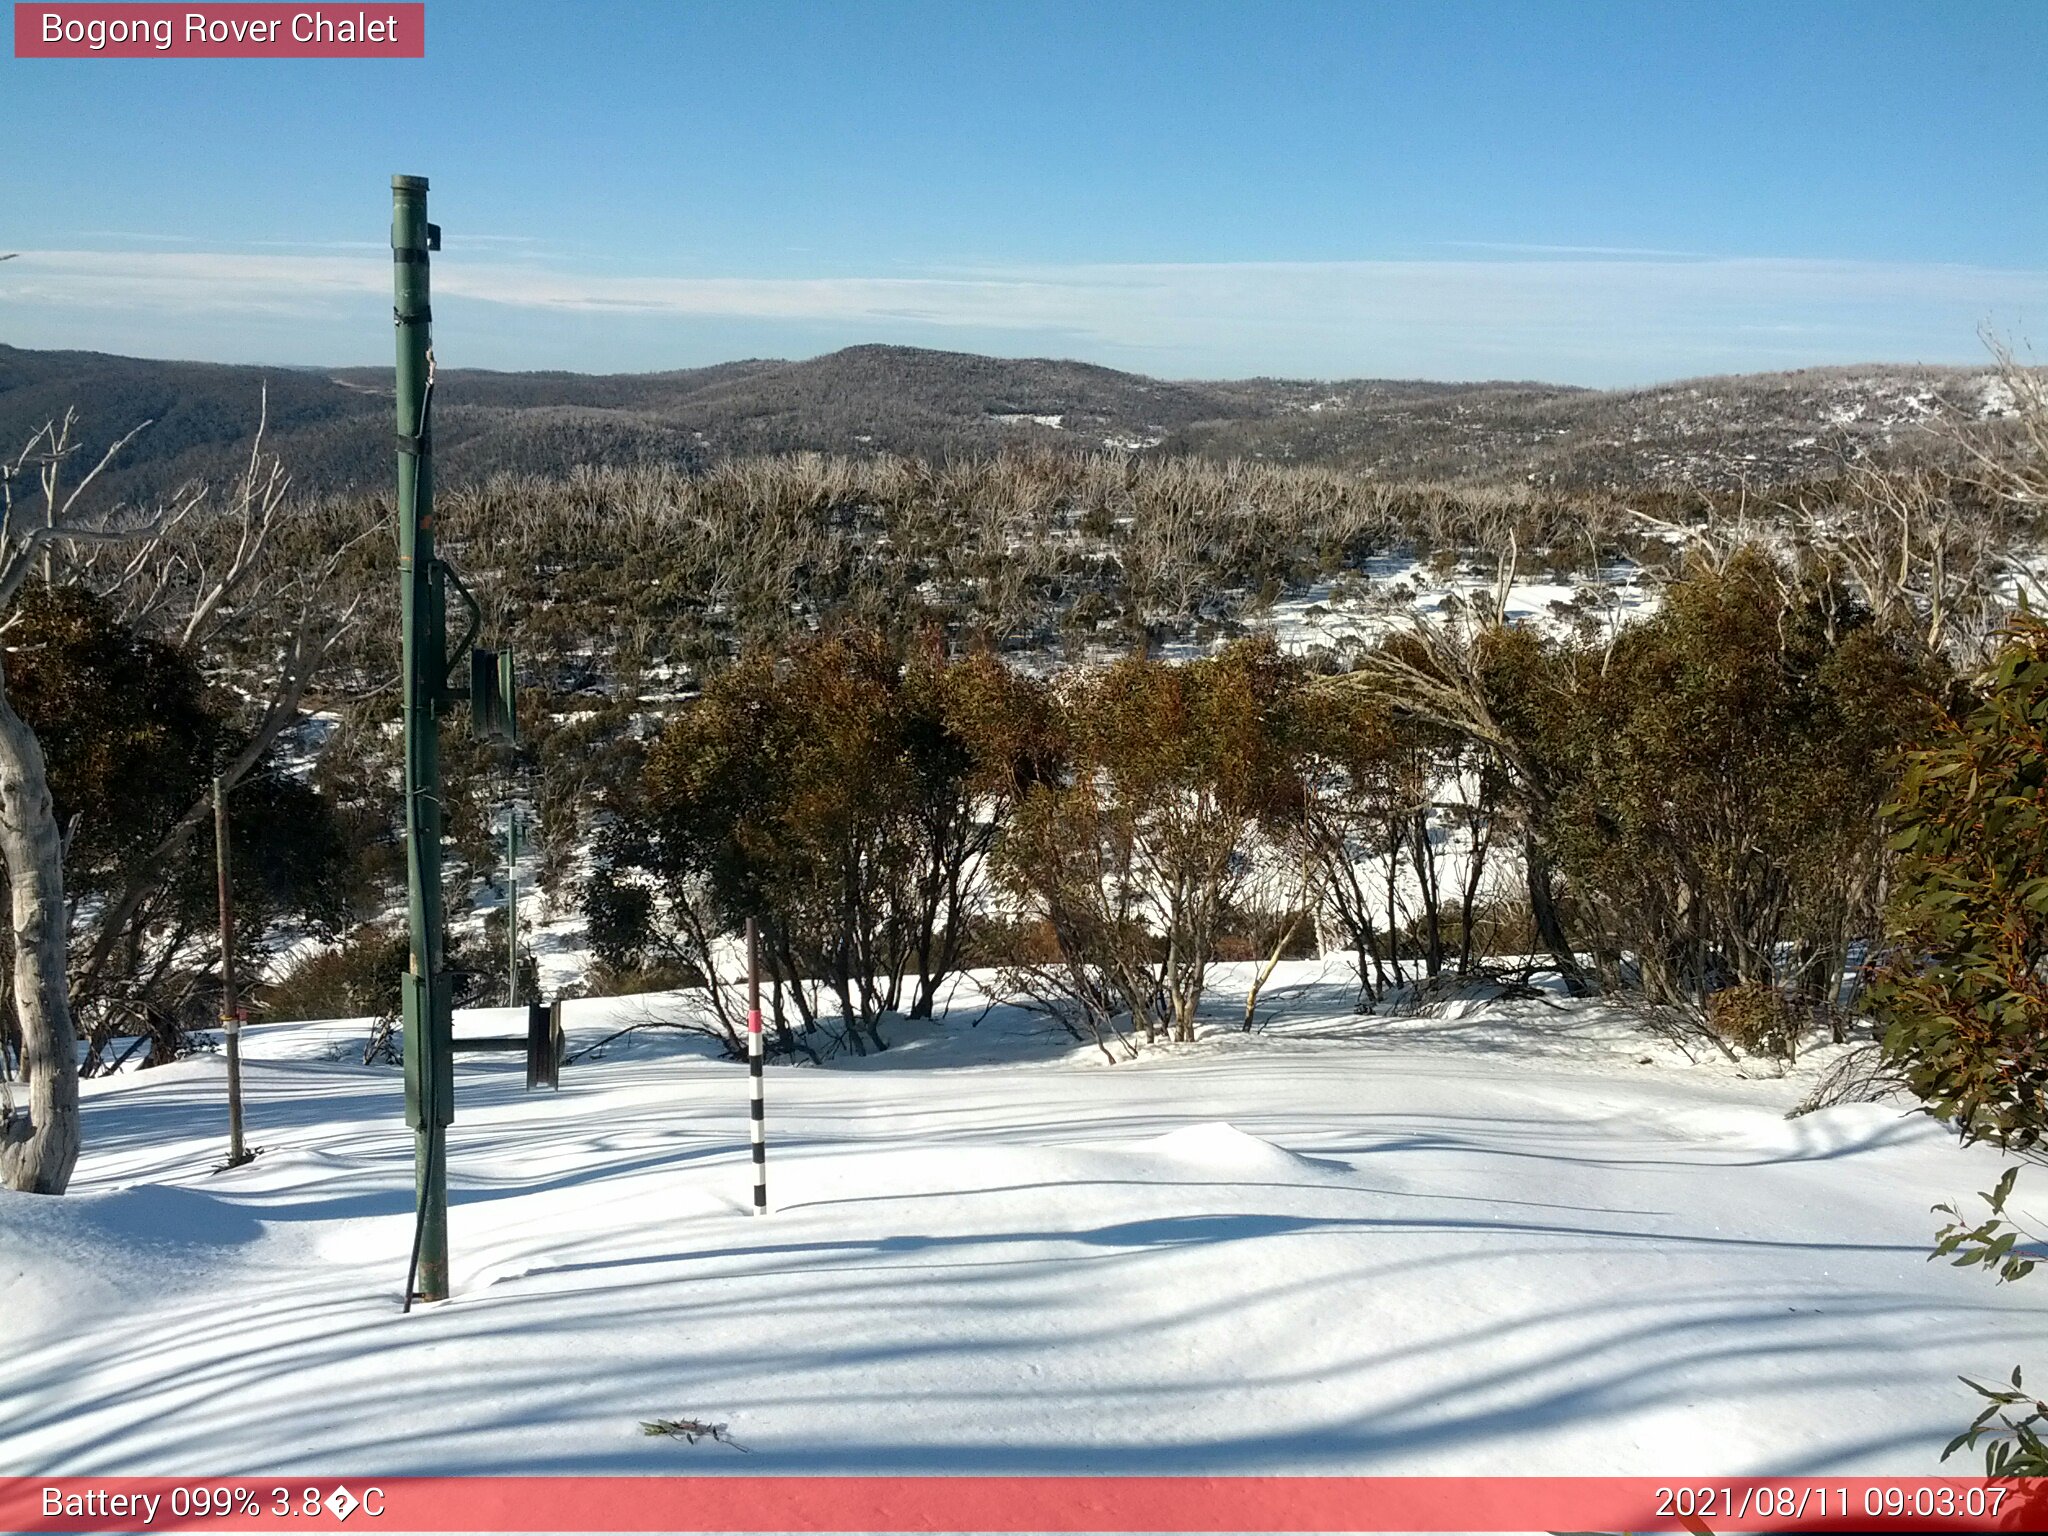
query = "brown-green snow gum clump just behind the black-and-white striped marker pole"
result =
(586, 631, 1044, 1053)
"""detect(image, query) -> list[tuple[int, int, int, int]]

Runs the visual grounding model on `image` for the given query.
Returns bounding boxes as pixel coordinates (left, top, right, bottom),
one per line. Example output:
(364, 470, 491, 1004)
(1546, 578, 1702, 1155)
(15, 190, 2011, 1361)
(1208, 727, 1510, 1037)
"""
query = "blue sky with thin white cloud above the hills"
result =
(0, 0, 2048, 385)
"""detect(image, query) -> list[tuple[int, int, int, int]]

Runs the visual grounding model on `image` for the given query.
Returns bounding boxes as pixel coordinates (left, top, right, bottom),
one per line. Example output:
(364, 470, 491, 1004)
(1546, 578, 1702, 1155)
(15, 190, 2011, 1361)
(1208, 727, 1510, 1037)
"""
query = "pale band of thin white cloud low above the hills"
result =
(0, 249, 2048, 383)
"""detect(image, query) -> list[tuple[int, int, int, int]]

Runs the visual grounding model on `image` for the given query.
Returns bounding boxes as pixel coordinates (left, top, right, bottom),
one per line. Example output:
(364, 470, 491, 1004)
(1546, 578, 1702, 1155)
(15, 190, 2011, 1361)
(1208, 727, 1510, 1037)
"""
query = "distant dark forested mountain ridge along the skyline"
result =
(0, 346, 2001, 500)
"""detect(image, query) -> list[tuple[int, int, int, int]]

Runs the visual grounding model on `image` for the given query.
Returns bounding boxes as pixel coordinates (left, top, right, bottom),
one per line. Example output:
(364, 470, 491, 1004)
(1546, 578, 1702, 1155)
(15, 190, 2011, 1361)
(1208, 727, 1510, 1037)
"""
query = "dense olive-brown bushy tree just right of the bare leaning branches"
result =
(1546, 555, 1937, 1024)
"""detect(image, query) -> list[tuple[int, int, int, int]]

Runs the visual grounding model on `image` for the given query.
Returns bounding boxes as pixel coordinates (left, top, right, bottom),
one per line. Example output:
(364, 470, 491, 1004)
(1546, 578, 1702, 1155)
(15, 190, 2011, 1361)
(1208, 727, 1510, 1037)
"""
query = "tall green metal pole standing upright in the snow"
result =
(391, 176, 455, 1307)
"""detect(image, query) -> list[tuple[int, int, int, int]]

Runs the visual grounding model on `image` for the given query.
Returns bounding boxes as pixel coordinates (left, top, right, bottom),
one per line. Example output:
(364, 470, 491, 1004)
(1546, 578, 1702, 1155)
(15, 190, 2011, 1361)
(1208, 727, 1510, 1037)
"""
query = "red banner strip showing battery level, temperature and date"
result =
(0, 1477, 2048, 1532)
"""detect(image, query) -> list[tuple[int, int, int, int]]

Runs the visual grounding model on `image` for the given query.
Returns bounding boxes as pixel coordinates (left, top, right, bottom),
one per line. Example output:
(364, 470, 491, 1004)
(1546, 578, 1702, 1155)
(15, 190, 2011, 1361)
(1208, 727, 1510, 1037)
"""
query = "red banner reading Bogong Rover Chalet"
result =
(14, 0, 426, 59)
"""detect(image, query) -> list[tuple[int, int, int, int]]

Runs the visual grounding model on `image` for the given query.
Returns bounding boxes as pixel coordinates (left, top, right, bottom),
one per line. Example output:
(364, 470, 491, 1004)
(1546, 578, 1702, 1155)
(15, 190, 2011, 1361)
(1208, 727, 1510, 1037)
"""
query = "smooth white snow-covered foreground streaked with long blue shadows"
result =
(0, 963, 2048, 1477)
